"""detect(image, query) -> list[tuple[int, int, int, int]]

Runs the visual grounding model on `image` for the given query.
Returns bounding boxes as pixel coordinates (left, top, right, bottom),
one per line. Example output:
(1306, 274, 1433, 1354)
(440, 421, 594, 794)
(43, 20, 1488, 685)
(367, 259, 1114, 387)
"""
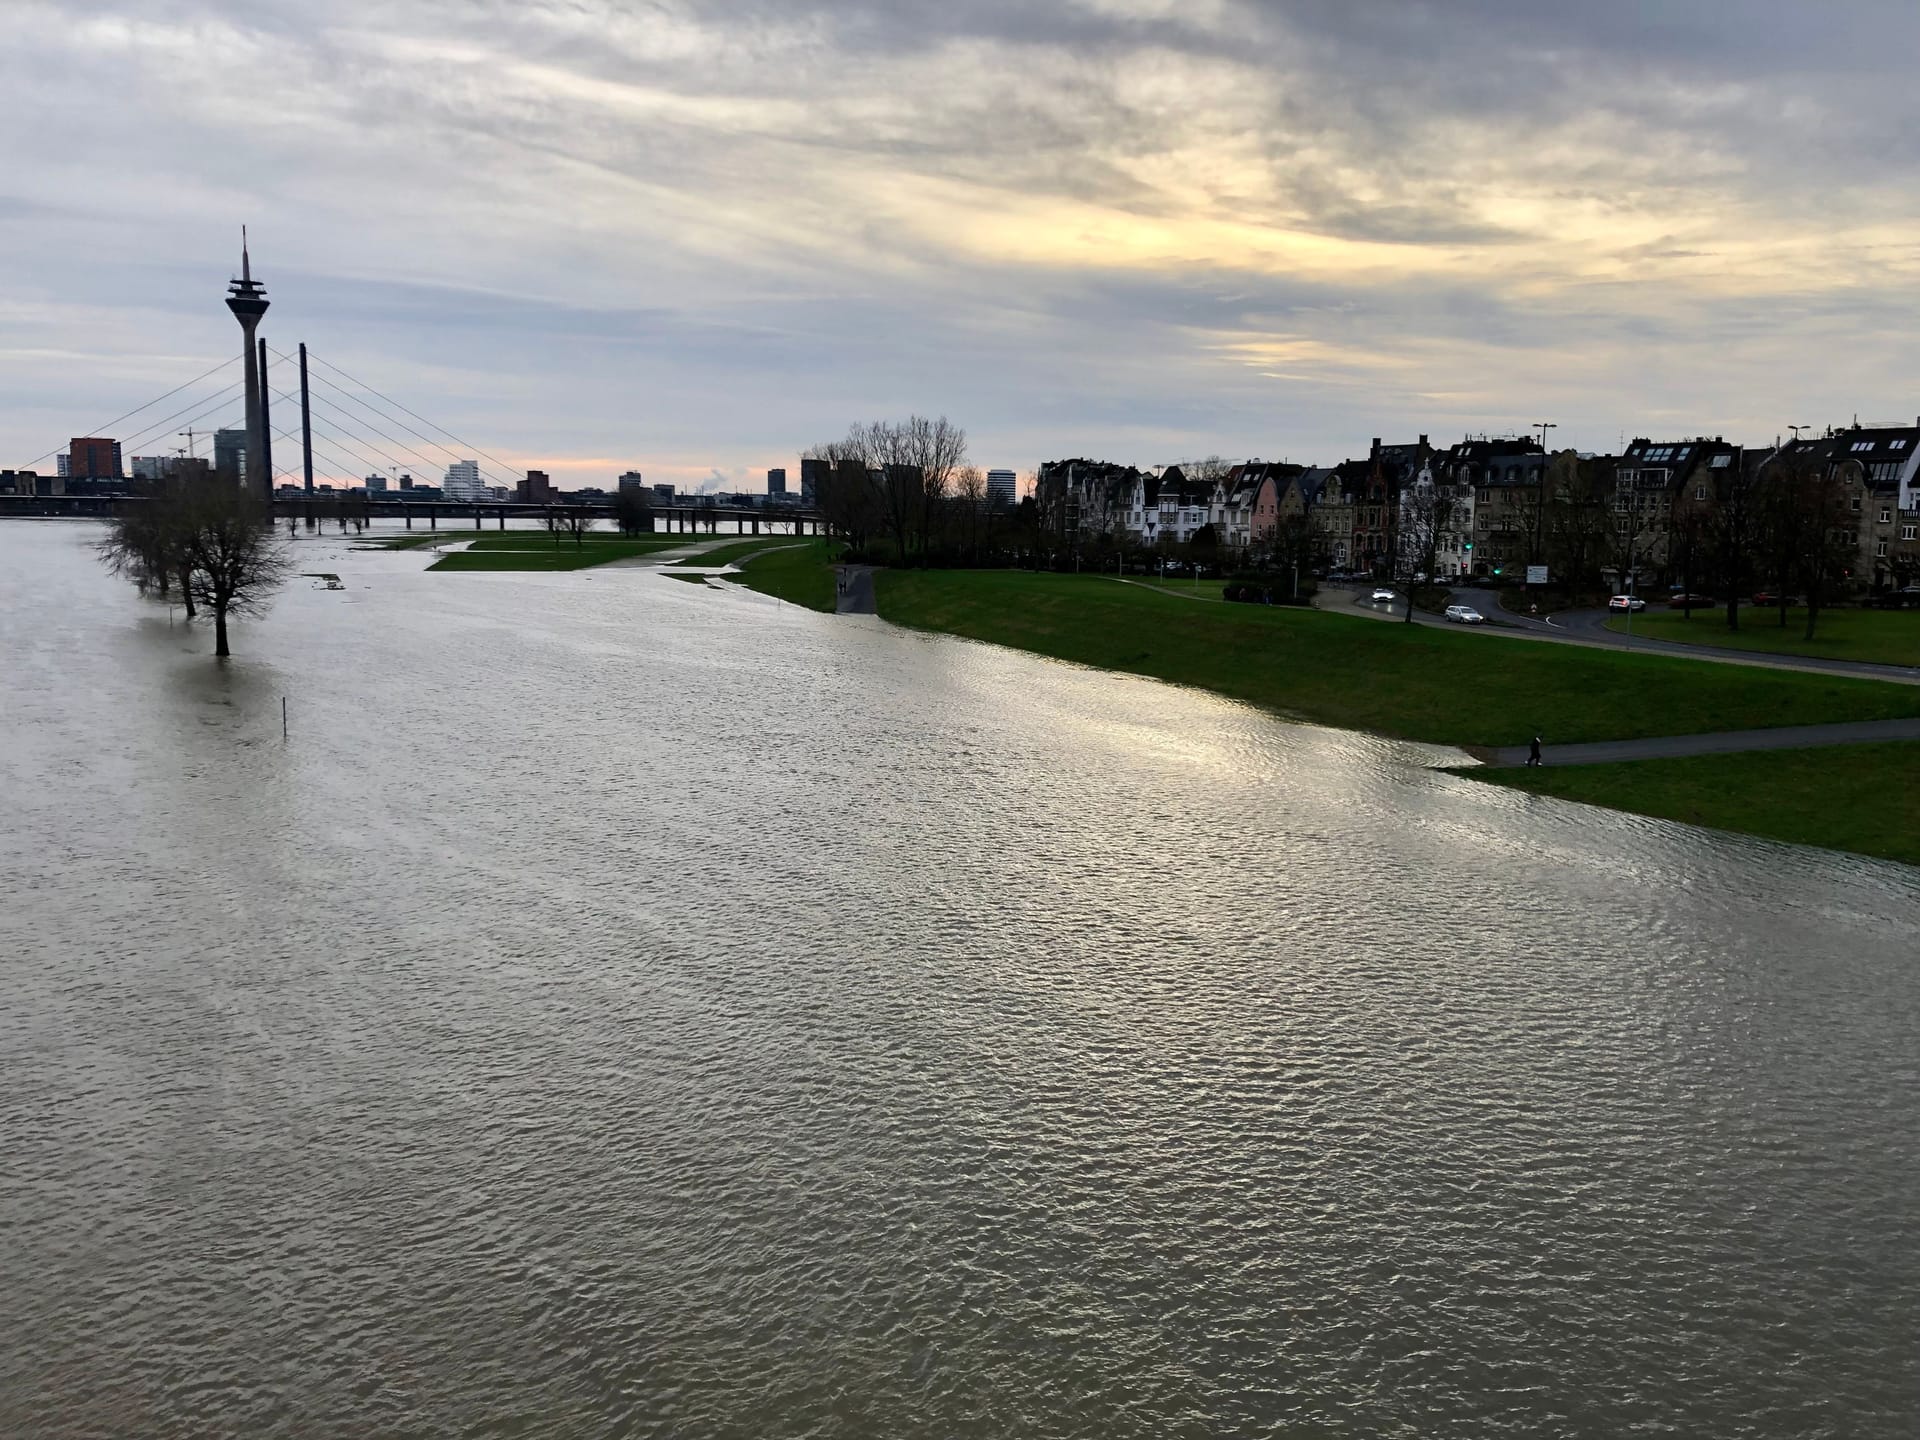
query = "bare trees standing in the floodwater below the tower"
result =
(98, 476, 290, 657)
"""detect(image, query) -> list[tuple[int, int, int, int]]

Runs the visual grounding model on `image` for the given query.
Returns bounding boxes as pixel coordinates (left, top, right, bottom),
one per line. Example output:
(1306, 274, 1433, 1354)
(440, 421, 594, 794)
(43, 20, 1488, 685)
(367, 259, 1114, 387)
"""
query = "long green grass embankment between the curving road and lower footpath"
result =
(875, 568, 1920, 745)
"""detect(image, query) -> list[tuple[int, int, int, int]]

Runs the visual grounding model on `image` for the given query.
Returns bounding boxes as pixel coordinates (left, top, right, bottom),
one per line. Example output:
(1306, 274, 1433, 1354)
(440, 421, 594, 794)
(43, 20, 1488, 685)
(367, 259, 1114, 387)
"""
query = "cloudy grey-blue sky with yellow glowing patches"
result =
(0, 0, 1920, 488)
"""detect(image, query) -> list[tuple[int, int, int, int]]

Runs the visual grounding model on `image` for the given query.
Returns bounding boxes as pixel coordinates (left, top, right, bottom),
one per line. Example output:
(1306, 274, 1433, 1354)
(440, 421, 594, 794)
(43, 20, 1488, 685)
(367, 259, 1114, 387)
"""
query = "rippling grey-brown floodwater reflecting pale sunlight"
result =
(0, 522, 1920, 1438)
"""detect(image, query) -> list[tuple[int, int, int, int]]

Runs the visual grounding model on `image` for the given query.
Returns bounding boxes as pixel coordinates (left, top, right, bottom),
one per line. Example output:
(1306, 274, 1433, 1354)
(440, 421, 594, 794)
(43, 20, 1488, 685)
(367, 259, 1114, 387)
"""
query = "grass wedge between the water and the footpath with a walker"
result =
(1461, 741, 1920, 864)
